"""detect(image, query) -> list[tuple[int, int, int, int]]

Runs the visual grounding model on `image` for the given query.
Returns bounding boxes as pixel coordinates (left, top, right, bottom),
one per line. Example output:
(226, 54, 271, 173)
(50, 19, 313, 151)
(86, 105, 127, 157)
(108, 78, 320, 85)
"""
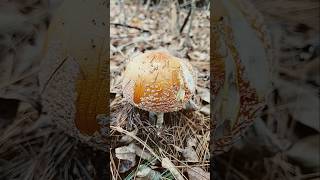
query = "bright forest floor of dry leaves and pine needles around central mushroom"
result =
(110, 0, 210, 179)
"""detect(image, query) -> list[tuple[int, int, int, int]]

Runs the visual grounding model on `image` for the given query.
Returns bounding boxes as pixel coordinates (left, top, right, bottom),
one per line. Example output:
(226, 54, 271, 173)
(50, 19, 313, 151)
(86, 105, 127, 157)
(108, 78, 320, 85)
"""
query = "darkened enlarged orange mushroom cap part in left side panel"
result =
(40, 0, 109, 150)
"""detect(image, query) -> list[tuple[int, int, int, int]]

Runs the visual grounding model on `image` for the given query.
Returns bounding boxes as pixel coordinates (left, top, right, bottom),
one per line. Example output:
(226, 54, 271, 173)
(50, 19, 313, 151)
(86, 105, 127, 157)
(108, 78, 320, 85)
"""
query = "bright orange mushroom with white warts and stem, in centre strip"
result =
(123, 51, 196, 128)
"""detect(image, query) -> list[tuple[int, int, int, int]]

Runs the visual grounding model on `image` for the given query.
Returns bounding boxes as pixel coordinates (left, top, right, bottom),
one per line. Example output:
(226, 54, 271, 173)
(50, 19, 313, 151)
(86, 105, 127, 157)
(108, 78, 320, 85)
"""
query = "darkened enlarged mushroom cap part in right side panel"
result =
(210, 0, 273, 155)
